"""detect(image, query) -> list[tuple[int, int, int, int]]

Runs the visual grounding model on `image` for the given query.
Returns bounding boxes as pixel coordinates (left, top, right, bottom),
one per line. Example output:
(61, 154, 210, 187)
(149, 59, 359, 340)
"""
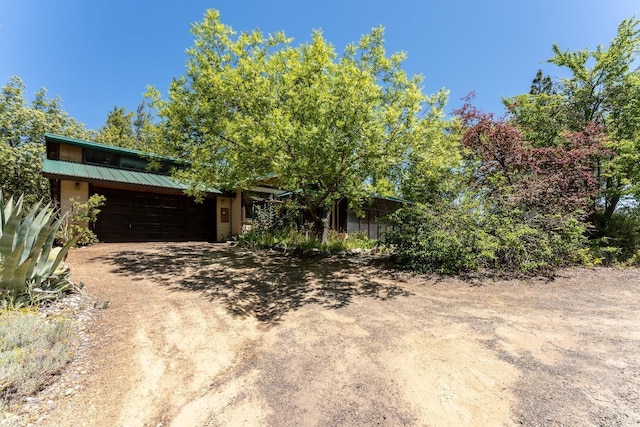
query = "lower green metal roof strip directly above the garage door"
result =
(42, 159, 222, 194)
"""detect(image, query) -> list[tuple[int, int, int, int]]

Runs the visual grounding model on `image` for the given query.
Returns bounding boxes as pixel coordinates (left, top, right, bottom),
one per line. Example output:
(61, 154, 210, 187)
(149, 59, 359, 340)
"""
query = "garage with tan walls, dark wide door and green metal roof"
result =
(43, 134, 225, 242)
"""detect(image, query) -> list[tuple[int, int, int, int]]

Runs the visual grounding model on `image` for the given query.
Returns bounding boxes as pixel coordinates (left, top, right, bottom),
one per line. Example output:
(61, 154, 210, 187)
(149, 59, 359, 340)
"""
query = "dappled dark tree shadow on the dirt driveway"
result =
(95, 245, 411, 323)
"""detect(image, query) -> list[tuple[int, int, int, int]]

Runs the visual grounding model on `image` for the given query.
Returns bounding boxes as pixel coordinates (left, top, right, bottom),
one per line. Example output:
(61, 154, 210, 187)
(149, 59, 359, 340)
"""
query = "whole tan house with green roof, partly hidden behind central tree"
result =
(42, 134, 402, 242)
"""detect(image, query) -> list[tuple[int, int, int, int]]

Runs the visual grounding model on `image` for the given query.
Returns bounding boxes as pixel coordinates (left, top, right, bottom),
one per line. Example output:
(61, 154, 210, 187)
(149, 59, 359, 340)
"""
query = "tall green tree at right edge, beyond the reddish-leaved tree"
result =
(505, 19, 640, 226)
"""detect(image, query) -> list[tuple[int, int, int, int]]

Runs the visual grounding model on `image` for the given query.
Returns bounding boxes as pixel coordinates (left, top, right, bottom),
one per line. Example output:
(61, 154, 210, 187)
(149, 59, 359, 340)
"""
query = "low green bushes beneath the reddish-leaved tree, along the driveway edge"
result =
(386, 198, 586, 274)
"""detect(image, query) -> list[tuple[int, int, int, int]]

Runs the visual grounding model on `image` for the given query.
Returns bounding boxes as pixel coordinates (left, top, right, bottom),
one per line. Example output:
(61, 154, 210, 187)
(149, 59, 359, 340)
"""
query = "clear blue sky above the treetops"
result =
(0, 0, 640, 129)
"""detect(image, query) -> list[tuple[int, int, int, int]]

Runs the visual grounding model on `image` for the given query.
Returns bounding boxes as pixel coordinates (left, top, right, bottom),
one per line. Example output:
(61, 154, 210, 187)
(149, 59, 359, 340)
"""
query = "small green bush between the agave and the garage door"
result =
(56, 194, 106, 246)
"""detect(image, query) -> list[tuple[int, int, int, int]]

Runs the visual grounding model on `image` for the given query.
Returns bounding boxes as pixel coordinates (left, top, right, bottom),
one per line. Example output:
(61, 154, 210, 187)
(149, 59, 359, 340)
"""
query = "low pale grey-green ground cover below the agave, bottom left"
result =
(0, 310, 73, 409)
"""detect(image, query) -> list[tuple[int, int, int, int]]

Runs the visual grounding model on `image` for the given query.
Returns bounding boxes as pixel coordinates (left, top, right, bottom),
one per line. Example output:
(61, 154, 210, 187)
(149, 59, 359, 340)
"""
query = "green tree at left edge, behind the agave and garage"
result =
(0, 77, 92, 204)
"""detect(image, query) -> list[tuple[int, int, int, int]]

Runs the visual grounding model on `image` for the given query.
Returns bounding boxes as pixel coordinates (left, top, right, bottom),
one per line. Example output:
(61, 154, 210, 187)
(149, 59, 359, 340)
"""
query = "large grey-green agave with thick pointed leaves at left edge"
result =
(0, 191, 75, 305)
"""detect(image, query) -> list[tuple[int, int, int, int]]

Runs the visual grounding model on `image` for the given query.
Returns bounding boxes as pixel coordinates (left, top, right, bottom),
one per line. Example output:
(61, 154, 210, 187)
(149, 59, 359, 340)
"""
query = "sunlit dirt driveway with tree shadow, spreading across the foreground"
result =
(40, 244, 640, 427)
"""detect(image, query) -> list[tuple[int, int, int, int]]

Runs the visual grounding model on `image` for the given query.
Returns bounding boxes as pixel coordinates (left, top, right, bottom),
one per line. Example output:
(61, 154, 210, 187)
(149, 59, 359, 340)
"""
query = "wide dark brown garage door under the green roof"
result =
(92, 187, 216, 242)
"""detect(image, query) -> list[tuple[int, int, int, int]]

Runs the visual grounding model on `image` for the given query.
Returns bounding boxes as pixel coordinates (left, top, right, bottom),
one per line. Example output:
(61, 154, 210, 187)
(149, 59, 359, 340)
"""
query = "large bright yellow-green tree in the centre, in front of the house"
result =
(149, 10, 446, 242)
